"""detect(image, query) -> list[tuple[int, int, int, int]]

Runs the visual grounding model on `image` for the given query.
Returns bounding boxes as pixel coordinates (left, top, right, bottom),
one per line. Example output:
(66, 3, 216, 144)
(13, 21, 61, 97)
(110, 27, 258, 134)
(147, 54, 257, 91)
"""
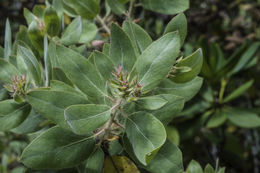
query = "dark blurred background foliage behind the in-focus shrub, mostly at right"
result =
(0, 0, 260, 173)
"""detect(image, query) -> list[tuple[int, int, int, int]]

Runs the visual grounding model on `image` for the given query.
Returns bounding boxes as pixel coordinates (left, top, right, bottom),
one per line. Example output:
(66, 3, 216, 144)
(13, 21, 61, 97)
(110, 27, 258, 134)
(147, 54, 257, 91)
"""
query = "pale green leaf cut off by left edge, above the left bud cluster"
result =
(0, 58, 20, 83)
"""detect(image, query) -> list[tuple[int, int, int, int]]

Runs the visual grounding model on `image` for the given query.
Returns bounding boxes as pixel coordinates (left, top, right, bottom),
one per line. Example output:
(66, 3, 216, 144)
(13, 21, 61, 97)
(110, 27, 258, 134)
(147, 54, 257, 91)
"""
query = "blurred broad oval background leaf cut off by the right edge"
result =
(223, 108, 260, 128)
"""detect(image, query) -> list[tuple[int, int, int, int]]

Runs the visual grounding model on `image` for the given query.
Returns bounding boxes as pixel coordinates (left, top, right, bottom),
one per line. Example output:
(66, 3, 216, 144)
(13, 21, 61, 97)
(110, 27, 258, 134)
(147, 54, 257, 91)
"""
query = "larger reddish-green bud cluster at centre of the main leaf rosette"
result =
(110, 66, 143, 101)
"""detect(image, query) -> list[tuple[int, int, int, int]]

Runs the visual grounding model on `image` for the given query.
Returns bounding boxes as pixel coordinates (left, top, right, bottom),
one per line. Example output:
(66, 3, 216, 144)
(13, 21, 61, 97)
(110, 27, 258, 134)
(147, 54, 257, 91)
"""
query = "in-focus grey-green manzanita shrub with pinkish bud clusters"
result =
(0, 0, 213, 173)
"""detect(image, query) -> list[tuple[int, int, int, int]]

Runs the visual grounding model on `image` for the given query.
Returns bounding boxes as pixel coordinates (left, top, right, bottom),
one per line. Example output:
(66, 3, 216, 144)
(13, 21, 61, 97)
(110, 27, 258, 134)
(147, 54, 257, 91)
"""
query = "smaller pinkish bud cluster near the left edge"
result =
(4, 75, 27, 97)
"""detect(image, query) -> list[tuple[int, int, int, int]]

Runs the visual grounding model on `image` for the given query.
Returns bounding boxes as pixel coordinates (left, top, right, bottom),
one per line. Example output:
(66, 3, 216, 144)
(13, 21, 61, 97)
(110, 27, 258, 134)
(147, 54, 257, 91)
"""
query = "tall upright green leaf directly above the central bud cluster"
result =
(109, 24, 137, 72)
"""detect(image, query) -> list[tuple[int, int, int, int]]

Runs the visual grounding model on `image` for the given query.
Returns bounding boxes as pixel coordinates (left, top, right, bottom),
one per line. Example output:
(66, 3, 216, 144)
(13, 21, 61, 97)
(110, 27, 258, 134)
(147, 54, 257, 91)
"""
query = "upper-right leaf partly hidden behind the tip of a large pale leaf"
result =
(164, 13, 187, 45)
